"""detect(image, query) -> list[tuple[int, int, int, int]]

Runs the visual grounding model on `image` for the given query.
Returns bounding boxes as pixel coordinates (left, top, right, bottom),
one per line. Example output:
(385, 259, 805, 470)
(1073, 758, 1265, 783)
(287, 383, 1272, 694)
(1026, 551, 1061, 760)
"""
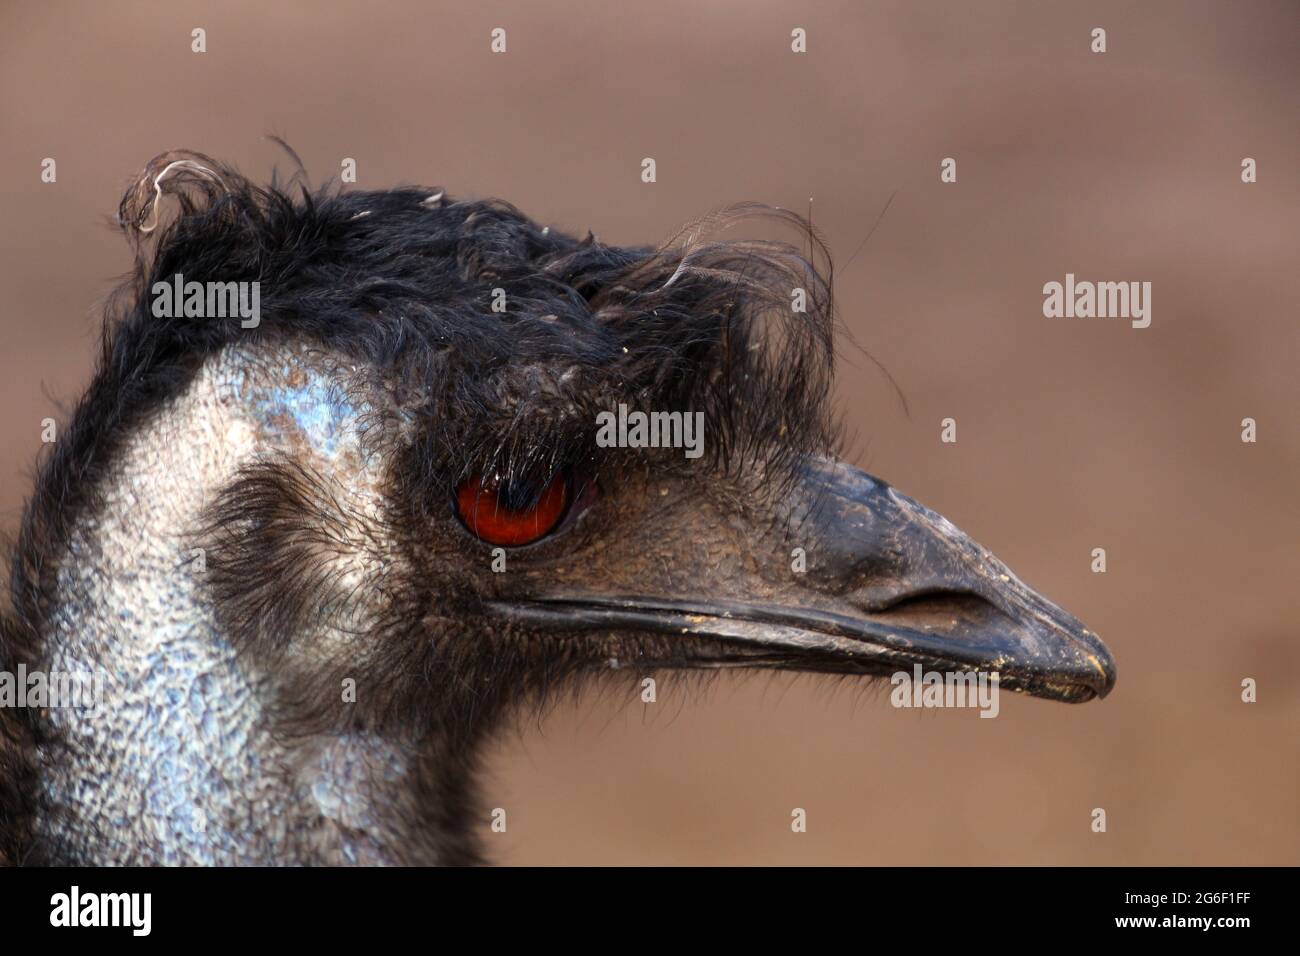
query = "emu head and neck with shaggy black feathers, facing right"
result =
(0, 152, 1115, 865)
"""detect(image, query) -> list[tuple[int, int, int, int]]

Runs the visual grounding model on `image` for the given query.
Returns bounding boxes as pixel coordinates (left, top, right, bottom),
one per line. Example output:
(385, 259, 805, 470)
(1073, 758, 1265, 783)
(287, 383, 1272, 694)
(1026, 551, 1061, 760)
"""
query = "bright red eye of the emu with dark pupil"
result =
(456, 472, 569, 548)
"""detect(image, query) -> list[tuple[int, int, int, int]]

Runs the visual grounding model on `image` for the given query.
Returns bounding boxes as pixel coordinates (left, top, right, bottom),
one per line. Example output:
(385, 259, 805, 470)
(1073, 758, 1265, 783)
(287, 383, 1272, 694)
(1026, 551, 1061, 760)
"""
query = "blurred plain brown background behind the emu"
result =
(0, 0, 1300, 864)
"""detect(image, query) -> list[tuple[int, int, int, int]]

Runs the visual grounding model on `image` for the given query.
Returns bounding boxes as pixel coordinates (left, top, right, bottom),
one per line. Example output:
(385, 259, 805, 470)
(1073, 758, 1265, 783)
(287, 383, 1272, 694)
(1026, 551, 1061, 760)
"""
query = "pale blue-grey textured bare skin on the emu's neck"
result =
(36, 346, 436, 865)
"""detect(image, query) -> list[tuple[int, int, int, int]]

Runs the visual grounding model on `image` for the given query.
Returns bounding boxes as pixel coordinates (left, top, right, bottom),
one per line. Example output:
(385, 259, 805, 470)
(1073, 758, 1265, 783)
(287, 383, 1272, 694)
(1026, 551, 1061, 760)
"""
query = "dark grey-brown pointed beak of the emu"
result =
(495, 460, 1115, 702)
